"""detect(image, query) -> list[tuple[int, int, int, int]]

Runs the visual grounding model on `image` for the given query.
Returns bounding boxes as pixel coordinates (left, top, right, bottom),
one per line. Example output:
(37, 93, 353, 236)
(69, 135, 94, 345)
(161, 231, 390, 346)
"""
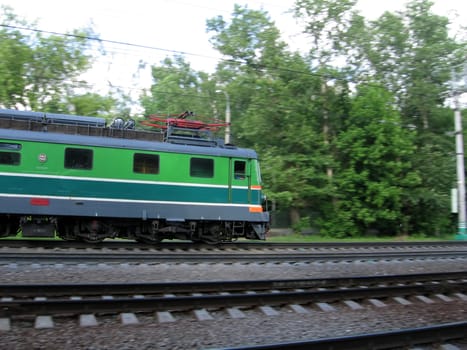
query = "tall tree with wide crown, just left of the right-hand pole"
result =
(349, 0, 467, 234)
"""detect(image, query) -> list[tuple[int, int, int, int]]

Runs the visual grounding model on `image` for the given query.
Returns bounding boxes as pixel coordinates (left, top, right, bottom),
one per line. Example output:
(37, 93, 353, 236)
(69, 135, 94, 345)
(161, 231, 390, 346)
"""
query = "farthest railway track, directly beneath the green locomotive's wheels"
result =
(0, 241, 467, 264)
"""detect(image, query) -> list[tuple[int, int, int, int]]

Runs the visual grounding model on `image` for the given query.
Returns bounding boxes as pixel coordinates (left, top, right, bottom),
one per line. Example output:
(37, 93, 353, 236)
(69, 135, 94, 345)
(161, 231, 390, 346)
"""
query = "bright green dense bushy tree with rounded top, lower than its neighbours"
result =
(323, 86, 421, 236)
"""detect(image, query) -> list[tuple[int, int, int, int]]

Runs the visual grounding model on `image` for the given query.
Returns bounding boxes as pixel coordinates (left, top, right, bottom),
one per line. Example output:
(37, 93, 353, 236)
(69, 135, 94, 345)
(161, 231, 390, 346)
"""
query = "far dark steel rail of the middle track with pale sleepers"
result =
(0, 271, 467, 298)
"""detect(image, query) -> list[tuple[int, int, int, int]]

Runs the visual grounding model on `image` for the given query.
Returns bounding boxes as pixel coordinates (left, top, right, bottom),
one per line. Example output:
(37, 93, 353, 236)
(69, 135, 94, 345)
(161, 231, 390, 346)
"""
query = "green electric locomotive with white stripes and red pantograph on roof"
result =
(0, 109, 269, 243)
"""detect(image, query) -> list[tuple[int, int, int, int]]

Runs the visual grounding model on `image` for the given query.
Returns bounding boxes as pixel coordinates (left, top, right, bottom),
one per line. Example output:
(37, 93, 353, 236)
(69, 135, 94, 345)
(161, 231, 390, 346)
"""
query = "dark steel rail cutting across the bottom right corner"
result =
(216, 321, 467, 350)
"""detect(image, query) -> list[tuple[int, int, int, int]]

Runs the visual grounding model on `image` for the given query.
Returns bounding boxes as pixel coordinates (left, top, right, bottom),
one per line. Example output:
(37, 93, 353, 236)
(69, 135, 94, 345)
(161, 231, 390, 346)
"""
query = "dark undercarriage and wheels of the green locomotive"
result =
(0, 216, 260, 244)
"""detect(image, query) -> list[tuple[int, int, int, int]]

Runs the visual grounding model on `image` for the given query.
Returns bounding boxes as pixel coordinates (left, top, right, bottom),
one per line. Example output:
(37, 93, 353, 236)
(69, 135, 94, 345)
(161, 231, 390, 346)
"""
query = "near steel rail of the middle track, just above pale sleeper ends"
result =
(0, 282, 467, 317)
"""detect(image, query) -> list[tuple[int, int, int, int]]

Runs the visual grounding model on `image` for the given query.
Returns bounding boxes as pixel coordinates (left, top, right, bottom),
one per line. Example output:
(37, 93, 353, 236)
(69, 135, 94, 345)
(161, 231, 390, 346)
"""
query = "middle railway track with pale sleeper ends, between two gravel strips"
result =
(0, 272, 467, 318)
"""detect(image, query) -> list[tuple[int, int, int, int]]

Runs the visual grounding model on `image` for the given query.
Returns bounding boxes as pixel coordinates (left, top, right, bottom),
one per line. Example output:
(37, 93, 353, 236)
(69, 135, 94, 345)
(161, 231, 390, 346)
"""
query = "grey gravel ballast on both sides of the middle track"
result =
(0, 259, 467, 350)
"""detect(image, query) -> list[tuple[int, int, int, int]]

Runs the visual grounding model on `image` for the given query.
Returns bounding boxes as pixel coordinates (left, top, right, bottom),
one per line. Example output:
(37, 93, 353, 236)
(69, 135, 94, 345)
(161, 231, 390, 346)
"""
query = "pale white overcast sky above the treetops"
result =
(0, 0, 467, 101)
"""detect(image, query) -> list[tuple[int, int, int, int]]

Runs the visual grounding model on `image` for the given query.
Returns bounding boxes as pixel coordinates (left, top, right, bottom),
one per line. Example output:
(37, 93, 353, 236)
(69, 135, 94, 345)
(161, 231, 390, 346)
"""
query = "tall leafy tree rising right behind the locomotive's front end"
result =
(208, 6, 350, 228)
